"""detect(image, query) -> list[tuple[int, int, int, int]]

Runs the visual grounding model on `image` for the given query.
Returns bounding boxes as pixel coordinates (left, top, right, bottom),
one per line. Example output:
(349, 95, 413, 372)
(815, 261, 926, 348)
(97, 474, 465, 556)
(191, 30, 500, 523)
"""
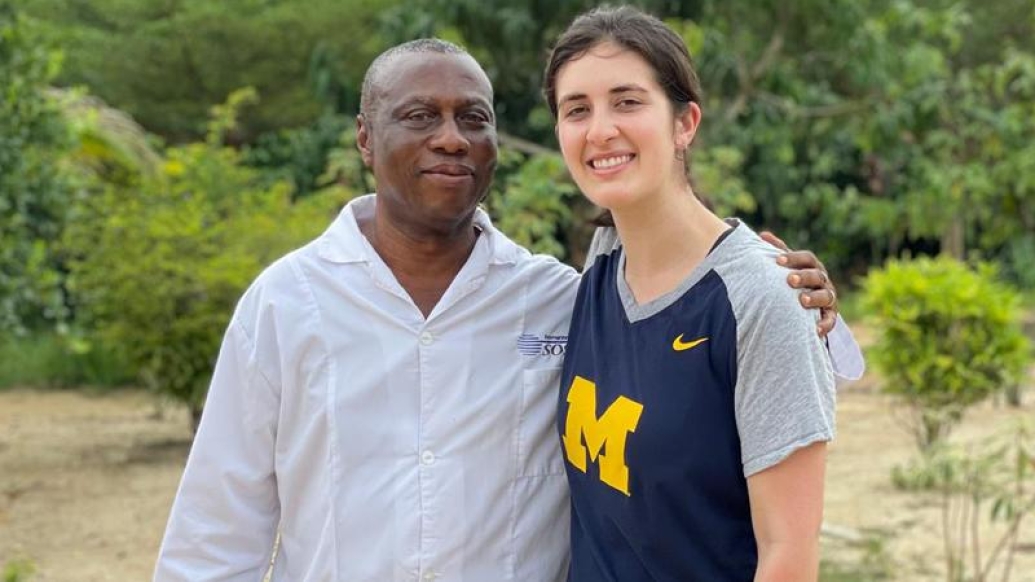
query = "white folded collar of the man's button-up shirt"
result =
(316, 194, 527, 265)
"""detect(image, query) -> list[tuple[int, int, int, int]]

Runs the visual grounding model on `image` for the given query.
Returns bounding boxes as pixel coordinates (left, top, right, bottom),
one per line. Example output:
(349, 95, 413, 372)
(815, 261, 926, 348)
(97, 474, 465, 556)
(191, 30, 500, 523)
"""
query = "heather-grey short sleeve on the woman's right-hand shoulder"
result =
(730, 259, 835, 476)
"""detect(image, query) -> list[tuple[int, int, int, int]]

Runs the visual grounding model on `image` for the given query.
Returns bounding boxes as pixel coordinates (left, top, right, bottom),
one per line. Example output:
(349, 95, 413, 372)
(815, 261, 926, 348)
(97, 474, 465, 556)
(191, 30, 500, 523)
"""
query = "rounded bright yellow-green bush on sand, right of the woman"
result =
(864, 257, 1029, 448)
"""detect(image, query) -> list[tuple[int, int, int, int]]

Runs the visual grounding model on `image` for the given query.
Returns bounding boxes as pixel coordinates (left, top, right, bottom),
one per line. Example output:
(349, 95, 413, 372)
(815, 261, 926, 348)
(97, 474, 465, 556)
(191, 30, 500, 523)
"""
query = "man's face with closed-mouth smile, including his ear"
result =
(357, 53, 497, 234)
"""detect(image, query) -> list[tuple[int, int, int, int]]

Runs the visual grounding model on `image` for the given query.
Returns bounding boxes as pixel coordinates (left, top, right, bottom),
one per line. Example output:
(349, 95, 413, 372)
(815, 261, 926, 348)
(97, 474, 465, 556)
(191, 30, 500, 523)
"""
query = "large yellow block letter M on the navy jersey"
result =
(562, 376, 644, 495)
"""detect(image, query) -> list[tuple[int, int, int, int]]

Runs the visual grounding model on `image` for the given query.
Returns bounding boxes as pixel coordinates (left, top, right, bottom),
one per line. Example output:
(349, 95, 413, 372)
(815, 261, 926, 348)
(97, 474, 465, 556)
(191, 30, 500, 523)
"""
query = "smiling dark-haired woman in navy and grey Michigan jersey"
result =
(544, 7, 834, 582)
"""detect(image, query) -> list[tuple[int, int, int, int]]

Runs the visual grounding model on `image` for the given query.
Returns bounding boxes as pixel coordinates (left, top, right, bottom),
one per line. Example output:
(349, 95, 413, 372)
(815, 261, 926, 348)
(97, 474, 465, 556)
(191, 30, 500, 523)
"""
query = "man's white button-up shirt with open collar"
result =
(154, 197, 579, 582)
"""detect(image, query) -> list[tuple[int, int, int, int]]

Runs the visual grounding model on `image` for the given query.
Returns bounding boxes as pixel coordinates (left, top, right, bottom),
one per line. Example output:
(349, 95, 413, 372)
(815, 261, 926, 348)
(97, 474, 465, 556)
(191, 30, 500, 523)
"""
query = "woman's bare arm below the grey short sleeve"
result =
(747, 442, 827, 582)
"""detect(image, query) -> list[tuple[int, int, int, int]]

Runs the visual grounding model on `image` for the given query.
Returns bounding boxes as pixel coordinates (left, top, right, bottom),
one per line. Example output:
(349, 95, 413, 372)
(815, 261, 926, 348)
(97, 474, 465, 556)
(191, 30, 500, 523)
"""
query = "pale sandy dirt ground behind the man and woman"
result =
(0, 382, 1035, 582)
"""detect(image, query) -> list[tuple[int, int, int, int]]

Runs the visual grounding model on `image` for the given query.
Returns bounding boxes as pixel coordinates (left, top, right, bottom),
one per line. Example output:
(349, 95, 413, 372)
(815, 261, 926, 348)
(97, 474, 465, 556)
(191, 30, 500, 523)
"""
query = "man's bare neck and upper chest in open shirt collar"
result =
(359, 212, 478, 319)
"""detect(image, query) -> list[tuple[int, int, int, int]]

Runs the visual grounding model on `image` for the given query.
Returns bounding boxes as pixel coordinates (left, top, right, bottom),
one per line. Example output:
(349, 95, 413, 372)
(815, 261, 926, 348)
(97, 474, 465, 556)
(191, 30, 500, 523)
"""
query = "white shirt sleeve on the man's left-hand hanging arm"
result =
(154, 317, 279, 582)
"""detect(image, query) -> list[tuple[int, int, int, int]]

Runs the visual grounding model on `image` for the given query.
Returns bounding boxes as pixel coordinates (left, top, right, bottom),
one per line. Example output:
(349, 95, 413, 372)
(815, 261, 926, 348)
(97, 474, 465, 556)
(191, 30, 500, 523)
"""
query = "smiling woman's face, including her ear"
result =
(557, 42, 701, 211)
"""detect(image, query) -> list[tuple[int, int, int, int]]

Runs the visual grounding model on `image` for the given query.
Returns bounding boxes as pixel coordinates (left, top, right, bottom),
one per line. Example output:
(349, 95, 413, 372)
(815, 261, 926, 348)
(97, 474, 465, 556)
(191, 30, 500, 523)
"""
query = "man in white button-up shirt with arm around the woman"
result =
(154, 40, 858, 582)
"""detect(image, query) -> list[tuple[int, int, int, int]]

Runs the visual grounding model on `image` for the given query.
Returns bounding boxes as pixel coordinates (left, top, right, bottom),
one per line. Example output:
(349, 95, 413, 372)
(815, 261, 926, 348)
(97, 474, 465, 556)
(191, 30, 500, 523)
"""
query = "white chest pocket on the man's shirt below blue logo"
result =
(518, 368, 564, 476)
